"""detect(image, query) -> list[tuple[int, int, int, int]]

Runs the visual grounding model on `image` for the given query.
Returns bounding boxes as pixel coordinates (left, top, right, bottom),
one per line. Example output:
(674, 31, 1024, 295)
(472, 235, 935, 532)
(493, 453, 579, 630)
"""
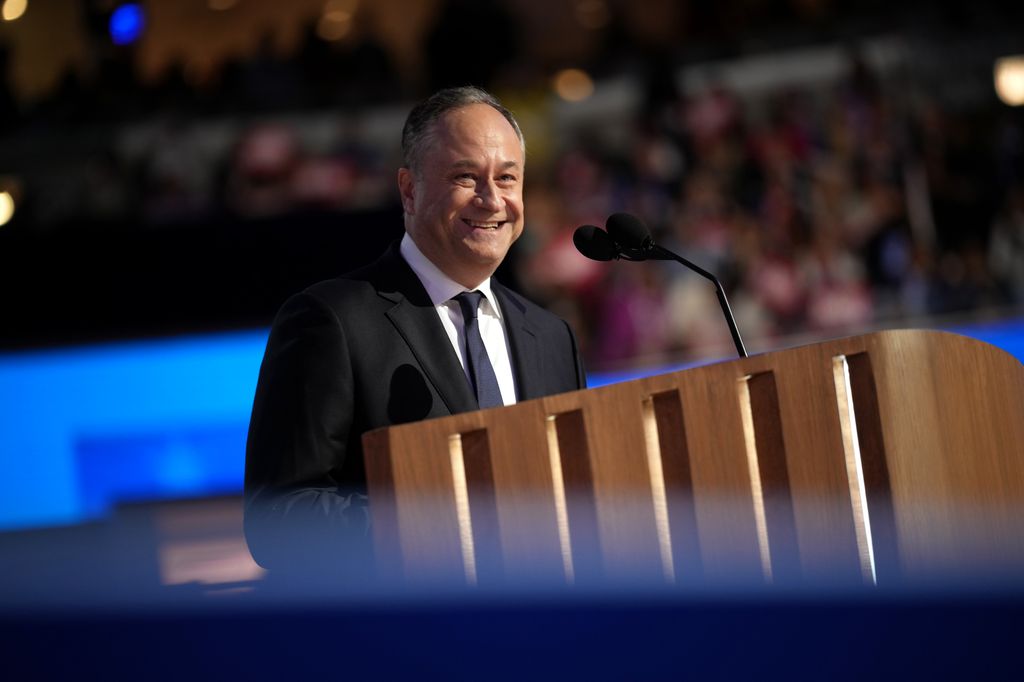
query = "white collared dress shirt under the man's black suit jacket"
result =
(398, 233, 515, 404)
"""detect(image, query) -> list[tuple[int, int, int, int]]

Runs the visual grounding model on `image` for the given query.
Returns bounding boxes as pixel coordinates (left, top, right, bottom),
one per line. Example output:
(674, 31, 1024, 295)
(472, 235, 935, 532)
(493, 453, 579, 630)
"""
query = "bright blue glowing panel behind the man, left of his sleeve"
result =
(0, 330, 267, 532)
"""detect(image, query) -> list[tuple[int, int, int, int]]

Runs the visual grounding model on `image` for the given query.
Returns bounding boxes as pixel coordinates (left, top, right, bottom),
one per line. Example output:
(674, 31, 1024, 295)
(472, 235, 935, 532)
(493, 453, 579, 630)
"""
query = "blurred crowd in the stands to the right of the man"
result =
(521, 59, 1024, 367)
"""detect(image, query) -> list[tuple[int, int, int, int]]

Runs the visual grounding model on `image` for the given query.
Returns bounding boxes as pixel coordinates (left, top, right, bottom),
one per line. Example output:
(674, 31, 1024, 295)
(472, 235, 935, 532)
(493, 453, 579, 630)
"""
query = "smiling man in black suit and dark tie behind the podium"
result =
(245, 87, 585, 567)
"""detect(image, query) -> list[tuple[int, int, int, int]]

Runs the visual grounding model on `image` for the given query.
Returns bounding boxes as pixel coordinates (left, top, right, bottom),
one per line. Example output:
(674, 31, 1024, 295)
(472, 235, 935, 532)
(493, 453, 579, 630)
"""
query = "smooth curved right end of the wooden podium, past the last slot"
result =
(866, 333, 1024, 578)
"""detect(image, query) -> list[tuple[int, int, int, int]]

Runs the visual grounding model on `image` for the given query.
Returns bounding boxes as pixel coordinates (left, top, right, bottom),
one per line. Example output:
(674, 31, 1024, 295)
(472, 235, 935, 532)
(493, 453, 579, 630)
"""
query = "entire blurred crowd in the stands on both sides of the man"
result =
(0, 11, 1024, 369)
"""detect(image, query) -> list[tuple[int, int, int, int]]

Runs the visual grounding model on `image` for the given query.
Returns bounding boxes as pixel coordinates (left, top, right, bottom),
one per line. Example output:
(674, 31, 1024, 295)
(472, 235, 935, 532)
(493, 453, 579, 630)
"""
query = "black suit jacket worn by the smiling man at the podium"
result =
(245, 244, 586, 567)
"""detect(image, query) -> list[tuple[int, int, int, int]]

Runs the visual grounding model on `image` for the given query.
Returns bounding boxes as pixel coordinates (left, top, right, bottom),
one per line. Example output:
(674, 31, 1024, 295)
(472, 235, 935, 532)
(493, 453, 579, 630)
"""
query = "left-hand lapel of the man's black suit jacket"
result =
(374, 245, 477, 414)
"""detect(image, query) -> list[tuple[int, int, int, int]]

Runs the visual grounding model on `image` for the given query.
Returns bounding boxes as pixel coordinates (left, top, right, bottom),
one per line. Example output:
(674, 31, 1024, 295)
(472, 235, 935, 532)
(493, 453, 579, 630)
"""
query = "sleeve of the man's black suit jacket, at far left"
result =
(245, 294, 369, 571)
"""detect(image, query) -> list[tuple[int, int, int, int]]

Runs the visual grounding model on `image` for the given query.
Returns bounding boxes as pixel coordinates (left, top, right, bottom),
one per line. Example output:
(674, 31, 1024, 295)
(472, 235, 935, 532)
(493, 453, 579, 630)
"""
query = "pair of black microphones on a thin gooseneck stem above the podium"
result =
(572, 213, 746, 357)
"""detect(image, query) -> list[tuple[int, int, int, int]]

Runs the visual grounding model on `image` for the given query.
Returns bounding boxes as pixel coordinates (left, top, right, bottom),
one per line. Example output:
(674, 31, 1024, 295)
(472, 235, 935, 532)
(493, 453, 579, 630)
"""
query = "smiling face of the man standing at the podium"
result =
(398, 104, 525, 288)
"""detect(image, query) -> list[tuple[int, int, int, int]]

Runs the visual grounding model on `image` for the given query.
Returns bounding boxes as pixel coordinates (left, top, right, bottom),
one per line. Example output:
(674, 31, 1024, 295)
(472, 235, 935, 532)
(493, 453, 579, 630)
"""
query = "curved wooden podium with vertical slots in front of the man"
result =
(364, 331, 1024, 585)
